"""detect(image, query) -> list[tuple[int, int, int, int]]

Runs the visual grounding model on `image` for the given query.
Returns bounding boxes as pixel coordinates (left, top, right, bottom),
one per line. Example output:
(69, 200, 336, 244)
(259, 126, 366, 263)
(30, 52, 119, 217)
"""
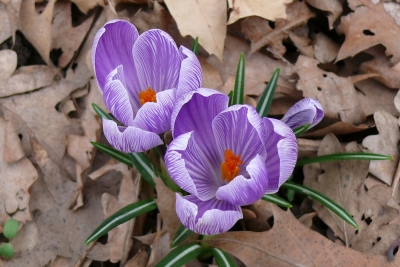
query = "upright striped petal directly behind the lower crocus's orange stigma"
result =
(210, 105, 267, 169)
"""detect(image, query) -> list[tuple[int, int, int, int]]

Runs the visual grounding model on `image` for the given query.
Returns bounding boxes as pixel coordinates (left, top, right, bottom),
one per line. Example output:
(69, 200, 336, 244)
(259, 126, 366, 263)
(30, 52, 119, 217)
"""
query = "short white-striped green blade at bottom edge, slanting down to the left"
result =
(155, 244, 203, 267)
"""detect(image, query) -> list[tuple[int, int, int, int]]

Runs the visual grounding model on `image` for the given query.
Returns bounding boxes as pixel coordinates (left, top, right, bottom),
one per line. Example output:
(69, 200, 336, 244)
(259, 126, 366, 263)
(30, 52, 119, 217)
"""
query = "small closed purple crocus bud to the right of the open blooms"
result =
(282, 98, 324, 129)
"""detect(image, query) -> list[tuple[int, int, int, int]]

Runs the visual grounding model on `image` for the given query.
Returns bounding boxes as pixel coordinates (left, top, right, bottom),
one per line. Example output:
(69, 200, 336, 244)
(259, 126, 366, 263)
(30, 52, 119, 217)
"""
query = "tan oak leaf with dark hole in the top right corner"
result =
(336, 0, 400, 64)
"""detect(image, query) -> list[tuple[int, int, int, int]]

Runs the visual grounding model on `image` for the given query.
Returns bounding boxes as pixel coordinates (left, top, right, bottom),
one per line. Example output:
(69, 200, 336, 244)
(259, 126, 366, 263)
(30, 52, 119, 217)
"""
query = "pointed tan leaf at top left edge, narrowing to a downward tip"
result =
(18, 0, 56, 65)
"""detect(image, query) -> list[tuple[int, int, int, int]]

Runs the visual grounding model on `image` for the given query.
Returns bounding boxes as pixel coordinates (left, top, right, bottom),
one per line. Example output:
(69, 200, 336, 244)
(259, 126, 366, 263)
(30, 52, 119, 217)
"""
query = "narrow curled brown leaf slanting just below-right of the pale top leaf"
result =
(250, 1, 314, 56)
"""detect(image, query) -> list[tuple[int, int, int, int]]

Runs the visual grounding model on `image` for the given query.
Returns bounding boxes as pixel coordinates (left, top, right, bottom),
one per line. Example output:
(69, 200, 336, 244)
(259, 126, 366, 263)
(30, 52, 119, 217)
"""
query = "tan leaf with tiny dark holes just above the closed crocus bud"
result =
(296, 56, 365, 125)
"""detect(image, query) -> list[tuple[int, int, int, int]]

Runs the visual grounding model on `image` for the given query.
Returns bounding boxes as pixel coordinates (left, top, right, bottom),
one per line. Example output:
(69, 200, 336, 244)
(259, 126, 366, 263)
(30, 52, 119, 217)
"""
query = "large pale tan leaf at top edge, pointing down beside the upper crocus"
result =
(164, 0, 227, 61)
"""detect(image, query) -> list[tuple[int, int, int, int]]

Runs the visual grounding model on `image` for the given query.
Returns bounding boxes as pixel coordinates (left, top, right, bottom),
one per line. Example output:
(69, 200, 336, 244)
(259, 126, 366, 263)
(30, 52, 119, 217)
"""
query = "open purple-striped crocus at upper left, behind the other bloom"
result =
(92, 20, 202, 152)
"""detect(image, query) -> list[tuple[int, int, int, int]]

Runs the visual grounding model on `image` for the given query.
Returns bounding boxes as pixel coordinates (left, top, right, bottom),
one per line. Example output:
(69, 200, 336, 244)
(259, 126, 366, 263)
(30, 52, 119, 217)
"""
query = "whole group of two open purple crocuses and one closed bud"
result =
(92, 20, 323, 235)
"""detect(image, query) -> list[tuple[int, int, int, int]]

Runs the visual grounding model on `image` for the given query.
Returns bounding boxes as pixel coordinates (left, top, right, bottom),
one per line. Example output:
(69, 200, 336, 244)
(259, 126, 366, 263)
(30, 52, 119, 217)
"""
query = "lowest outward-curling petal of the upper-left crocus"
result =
(103, 119, 163, 153)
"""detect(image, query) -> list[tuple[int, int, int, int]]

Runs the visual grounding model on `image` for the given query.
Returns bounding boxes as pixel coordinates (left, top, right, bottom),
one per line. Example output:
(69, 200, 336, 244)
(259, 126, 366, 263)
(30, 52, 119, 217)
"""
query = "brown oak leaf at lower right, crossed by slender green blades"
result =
(304, 134, 400, 255)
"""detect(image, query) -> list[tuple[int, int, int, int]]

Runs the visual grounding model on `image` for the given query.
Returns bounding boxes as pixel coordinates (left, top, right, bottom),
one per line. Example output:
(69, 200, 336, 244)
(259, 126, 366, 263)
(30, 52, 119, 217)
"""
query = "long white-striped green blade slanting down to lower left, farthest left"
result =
(85, 199, 157, 245)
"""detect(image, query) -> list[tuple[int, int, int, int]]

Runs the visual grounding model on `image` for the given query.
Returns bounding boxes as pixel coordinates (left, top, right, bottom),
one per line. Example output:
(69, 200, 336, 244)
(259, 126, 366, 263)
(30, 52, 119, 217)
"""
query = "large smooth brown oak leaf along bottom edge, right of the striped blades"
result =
(208, 206, 395, 267)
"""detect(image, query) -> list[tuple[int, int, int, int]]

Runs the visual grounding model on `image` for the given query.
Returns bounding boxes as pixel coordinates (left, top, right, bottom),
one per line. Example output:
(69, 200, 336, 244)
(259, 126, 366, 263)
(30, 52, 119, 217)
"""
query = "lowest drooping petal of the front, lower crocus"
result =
(176, 194, 243, 235)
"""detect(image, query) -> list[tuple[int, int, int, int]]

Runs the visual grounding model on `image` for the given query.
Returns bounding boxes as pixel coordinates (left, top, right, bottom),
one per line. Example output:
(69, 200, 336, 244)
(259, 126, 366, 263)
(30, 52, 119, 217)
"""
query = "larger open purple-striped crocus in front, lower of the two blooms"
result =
(165, 88, 297, 235)
